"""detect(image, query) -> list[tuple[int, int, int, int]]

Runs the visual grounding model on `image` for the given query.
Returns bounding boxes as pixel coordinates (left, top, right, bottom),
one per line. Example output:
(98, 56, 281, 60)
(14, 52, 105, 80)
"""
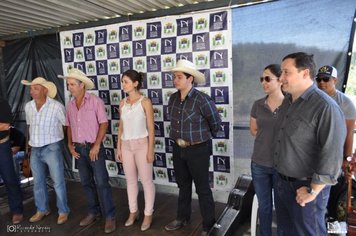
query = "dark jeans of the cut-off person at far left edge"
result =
(0, 141, 23, 214)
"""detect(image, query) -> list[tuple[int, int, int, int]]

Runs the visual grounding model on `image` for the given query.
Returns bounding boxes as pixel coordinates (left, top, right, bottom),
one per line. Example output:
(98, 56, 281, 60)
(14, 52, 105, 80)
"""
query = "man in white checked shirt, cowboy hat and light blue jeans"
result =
(21, 77, 69, 224)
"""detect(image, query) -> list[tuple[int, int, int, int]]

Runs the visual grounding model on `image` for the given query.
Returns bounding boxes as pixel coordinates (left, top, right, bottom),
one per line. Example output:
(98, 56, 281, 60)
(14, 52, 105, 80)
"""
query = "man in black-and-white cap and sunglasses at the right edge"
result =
(316, 65, 356, 218)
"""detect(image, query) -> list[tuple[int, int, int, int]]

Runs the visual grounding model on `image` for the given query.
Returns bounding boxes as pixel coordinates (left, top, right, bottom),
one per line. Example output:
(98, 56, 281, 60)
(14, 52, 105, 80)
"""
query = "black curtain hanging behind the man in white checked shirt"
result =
(3, 35, 74, 179)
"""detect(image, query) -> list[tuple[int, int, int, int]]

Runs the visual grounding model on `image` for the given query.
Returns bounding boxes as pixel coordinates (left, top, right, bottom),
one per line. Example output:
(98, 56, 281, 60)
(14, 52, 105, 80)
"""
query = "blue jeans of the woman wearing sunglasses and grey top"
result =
(251, 162, 275, 236)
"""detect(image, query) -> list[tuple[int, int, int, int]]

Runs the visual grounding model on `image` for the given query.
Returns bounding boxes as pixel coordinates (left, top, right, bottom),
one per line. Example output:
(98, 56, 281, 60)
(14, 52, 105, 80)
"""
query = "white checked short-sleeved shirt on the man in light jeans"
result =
(25, 97, 65, 147)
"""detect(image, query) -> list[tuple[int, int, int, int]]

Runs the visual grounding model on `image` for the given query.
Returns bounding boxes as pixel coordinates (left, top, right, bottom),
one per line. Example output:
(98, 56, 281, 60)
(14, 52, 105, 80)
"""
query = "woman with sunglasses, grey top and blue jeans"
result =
(250, 64, 284, 236)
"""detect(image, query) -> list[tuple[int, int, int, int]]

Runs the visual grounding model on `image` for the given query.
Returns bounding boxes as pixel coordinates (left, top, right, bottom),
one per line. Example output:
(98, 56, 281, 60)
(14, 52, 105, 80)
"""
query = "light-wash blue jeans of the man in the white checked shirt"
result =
(30, 141, 69, 214)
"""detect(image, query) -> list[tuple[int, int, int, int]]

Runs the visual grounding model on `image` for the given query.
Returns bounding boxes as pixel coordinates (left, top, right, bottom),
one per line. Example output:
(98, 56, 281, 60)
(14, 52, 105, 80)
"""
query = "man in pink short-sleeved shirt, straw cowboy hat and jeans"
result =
(58, 68, 116, 233)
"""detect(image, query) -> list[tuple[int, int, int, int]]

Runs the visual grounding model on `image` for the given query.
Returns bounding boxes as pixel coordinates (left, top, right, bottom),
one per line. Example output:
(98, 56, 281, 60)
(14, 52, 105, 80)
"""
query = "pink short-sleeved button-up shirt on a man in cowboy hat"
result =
(66, 93, 108, 143)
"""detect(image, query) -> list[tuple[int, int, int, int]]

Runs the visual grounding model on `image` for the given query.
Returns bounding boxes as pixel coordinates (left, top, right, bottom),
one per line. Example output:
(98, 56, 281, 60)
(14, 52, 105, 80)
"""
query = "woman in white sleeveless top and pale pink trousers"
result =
(117, 70, 155, 231)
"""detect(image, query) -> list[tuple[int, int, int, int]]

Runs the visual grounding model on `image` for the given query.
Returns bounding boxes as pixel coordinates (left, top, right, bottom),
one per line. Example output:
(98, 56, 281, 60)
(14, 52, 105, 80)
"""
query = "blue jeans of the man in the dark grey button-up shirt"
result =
(274, 174, 331, 236)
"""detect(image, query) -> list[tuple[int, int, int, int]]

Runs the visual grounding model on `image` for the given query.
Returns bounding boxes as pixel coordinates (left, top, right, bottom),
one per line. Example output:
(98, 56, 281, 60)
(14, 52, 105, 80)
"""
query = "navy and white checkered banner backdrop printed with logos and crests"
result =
(60, 10, 234, 190)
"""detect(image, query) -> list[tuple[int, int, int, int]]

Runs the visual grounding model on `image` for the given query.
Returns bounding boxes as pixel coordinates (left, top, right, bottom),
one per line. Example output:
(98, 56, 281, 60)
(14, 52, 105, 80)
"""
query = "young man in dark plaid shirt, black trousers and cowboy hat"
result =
(165, 60, 221, 235)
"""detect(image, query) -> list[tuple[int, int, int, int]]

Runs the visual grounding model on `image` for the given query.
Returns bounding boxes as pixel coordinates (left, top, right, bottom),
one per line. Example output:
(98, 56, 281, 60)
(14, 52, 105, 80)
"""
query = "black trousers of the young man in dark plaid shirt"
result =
(173, 142, 215, 231)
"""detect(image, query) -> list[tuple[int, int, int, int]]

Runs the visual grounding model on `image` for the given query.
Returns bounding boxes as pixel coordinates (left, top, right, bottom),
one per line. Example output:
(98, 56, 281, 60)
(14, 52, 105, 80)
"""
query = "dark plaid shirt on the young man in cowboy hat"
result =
(168, 88, 221, 142)
